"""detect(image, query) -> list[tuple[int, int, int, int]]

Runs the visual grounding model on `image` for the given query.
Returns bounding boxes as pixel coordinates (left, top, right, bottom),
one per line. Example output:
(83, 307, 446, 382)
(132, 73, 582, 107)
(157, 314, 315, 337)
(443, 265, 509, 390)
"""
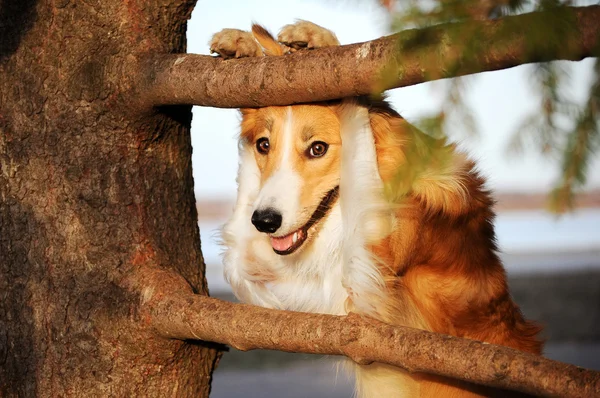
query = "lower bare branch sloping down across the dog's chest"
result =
(146, 293, 600, 397)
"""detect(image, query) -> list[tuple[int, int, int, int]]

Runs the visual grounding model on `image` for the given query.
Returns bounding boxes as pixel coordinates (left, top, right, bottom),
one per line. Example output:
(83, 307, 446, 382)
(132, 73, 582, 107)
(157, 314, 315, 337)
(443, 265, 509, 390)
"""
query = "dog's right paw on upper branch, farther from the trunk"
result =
(277, 21, 340, 52)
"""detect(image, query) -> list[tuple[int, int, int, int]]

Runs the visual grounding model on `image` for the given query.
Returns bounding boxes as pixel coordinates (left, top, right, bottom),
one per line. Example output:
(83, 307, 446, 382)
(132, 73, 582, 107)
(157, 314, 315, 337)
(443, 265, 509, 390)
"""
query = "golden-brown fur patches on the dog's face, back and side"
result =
(216, 22, 542, 397)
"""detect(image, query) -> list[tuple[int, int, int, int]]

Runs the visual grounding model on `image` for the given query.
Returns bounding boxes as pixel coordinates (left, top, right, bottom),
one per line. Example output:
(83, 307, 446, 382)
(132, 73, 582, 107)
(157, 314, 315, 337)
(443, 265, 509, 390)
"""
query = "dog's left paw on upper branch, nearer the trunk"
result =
(210, 29, 263, 59)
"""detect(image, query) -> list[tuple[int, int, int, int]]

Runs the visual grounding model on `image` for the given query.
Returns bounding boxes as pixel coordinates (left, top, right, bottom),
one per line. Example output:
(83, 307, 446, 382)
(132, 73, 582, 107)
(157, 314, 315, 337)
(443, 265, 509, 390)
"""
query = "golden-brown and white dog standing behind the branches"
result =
(211, 21, 542, 397)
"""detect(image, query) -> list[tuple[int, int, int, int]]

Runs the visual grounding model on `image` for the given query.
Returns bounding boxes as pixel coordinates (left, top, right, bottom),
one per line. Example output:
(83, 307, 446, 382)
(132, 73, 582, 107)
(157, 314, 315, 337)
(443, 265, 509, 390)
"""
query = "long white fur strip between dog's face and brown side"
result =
(340, 102, 419, 398)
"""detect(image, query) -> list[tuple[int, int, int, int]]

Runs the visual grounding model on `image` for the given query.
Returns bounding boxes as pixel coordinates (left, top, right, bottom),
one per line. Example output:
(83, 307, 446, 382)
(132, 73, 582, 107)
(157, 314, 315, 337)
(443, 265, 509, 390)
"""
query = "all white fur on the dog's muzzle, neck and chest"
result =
(223, 104, 417, 398)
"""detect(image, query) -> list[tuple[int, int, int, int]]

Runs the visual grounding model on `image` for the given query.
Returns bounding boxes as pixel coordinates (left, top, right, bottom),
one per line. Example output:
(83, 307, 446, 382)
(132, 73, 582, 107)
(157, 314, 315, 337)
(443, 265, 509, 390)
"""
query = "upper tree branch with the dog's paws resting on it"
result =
(142, 6, 600, 108)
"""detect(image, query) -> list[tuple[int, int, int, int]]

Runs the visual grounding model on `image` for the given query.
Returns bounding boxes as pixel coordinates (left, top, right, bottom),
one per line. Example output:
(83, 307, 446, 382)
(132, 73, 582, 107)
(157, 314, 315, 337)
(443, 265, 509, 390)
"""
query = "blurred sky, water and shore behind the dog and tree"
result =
(188, 0, 600, 398)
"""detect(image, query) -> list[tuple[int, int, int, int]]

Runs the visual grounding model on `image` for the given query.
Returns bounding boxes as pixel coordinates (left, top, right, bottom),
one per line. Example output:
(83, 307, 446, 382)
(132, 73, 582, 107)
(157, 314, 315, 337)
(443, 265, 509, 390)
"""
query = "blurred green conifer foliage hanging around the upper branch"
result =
(383, 0, 600, 212)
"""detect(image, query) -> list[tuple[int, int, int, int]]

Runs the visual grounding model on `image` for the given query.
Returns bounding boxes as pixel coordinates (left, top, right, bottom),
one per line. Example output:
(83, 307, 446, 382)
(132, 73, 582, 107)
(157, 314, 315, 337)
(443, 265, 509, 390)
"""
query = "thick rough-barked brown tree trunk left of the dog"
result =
(0, 0, 219, 397)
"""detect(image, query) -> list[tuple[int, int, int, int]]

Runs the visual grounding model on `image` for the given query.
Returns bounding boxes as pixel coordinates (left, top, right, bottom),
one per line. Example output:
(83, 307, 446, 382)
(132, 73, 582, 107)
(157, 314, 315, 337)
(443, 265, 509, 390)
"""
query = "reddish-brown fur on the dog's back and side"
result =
(354, 102, 542, 397)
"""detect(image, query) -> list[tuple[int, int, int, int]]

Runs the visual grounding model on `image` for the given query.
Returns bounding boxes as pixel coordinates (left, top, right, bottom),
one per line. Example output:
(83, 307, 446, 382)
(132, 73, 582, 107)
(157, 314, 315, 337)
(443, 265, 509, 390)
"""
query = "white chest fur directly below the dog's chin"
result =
(223, 195, 347, 314)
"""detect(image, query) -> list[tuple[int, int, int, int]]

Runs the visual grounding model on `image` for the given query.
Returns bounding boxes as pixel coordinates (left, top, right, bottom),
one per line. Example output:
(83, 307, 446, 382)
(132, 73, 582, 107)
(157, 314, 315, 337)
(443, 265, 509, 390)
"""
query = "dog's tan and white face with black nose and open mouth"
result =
(241, 105, 341, 255)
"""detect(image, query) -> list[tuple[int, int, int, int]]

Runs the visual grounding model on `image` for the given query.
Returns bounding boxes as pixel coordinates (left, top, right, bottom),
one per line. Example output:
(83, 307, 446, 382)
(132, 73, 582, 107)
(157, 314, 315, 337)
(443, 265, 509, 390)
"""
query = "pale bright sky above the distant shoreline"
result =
(188, 0, 600, 200)
